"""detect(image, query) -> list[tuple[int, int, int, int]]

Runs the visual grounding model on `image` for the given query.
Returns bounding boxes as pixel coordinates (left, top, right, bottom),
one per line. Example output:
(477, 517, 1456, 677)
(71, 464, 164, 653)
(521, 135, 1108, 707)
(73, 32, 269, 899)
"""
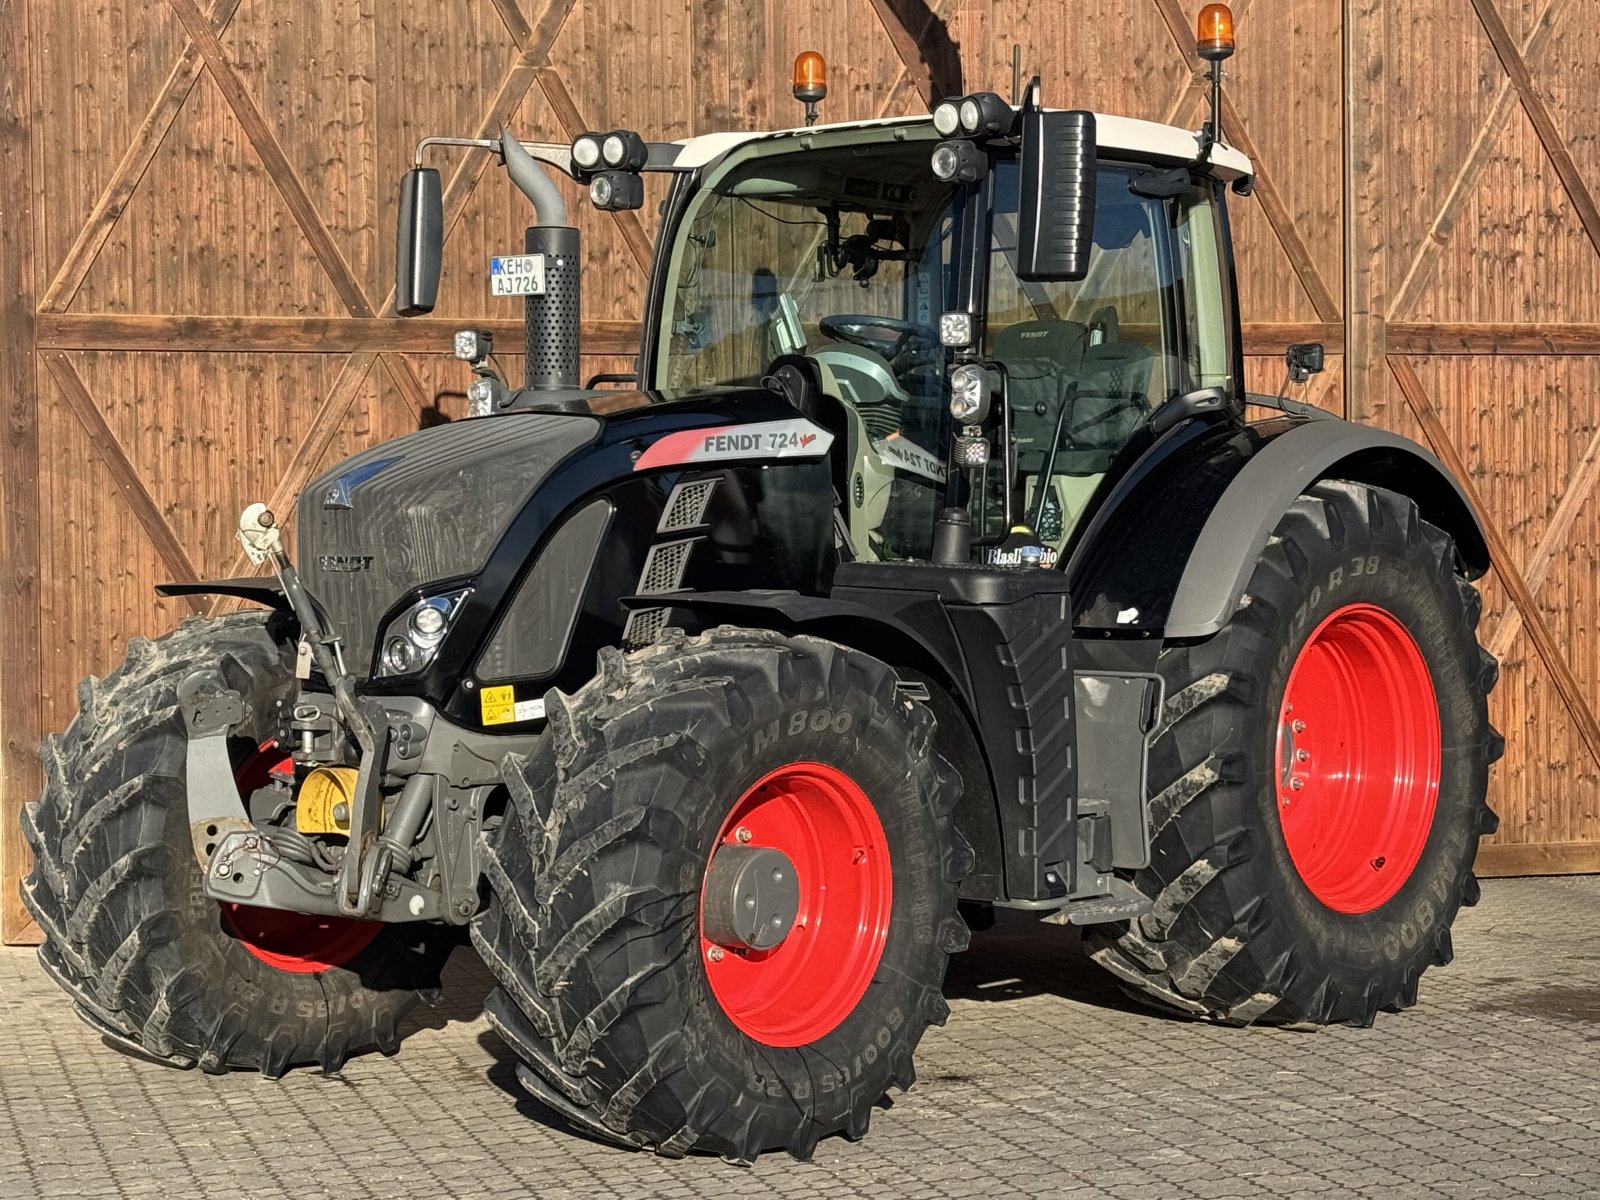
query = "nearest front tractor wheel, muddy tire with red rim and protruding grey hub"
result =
(472, 627, 971, 1163)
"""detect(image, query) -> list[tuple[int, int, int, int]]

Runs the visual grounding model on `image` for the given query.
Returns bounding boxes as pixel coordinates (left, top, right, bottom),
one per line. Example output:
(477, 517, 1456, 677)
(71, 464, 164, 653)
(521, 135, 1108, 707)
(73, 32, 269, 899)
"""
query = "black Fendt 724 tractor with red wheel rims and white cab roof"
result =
(22, 10, 1501, 1162)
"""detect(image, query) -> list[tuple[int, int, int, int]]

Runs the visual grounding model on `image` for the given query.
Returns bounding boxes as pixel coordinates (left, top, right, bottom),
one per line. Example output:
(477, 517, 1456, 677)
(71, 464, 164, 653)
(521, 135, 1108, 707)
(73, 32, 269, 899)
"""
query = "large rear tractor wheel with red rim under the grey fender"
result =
(1085, 482, 1502, 1026)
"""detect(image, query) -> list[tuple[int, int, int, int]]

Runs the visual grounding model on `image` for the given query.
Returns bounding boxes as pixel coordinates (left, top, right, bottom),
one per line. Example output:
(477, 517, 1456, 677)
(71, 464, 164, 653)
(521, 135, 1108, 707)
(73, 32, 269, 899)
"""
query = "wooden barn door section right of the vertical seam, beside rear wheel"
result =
(1349, 0, 1600, 874)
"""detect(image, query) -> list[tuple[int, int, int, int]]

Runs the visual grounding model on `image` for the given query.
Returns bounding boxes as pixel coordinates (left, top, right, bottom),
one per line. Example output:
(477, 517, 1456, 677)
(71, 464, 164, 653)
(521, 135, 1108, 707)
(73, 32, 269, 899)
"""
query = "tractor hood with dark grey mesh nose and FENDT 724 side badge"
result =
(296, 387, 830, 677)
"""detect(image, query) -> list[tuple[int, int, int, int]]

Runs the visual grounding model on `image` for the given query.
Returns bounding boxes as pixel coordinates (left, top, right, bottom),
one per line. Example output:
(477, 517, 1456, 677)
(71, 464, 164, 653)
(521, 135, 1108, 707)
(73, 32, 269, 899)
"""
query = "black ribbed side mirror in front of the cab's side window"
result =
(1016, 107, 1098, 283)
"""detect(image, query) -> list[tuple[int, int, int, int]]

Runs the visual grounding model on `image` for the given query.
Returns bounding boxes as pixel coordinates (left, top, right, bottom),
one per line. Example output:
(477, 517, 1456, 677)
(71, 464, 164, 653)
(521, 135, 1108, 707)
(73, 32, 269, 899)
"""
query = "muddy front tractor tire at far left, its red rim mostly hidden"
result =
(22, 613, 456, 1077)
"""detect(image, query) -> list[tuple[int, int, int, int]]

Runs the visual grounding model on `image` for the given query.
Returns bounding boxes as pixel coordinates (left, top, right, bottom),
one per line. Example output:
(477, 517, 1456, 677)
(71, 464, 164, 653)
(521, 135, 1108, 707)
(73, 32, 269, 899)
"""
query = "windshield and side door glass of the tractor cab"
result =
(653, 128, 1237, 560)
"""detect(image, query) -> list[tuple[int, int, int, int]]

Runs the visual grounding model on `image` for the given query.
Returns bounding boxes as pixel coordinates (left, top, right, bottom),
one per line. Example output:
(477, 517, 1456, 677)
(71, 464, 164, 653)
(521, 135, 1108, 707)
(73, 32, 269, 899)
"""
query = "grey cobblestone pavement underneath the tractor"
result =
(0, 878, 1600, 1200)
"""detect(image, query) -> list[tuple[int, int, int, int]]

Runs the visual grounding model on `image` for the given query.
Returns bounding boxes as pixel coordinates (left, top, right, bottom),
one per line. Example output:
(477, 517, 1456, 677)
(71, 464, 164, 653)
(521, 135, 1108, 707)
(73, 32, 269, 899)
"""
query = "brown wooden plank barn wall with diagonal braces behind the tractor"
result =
(0, 0, 1600, 941)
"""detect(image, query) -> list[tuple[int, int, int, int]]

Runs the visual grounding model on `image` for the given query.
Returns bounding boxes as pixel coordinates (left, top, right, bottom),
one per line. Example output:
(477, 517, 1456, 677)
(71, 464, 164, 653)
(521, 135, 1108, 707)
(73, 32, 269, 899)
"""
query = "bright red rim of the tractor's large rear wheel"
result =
(1277, 605, 1440, 914)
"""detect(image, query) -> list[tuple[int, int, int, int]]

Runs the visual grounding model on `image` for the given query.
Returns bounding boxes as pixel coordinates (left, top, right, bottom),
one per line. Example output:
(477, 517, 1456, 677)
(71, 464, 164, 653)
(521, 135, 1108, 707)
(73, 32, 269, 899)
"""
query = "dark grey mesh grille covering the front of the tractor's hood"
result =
(296, 413, 600, 677)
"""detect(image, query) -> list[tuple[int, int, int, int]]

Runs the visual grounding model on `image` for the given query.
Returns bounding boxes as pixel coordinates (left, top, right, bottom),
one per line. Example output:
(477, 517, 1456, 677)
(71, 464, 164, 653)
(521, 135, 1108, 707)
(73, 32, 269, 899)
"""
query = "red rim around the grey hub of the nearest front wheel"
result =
(699, 763, 893, 1046)
